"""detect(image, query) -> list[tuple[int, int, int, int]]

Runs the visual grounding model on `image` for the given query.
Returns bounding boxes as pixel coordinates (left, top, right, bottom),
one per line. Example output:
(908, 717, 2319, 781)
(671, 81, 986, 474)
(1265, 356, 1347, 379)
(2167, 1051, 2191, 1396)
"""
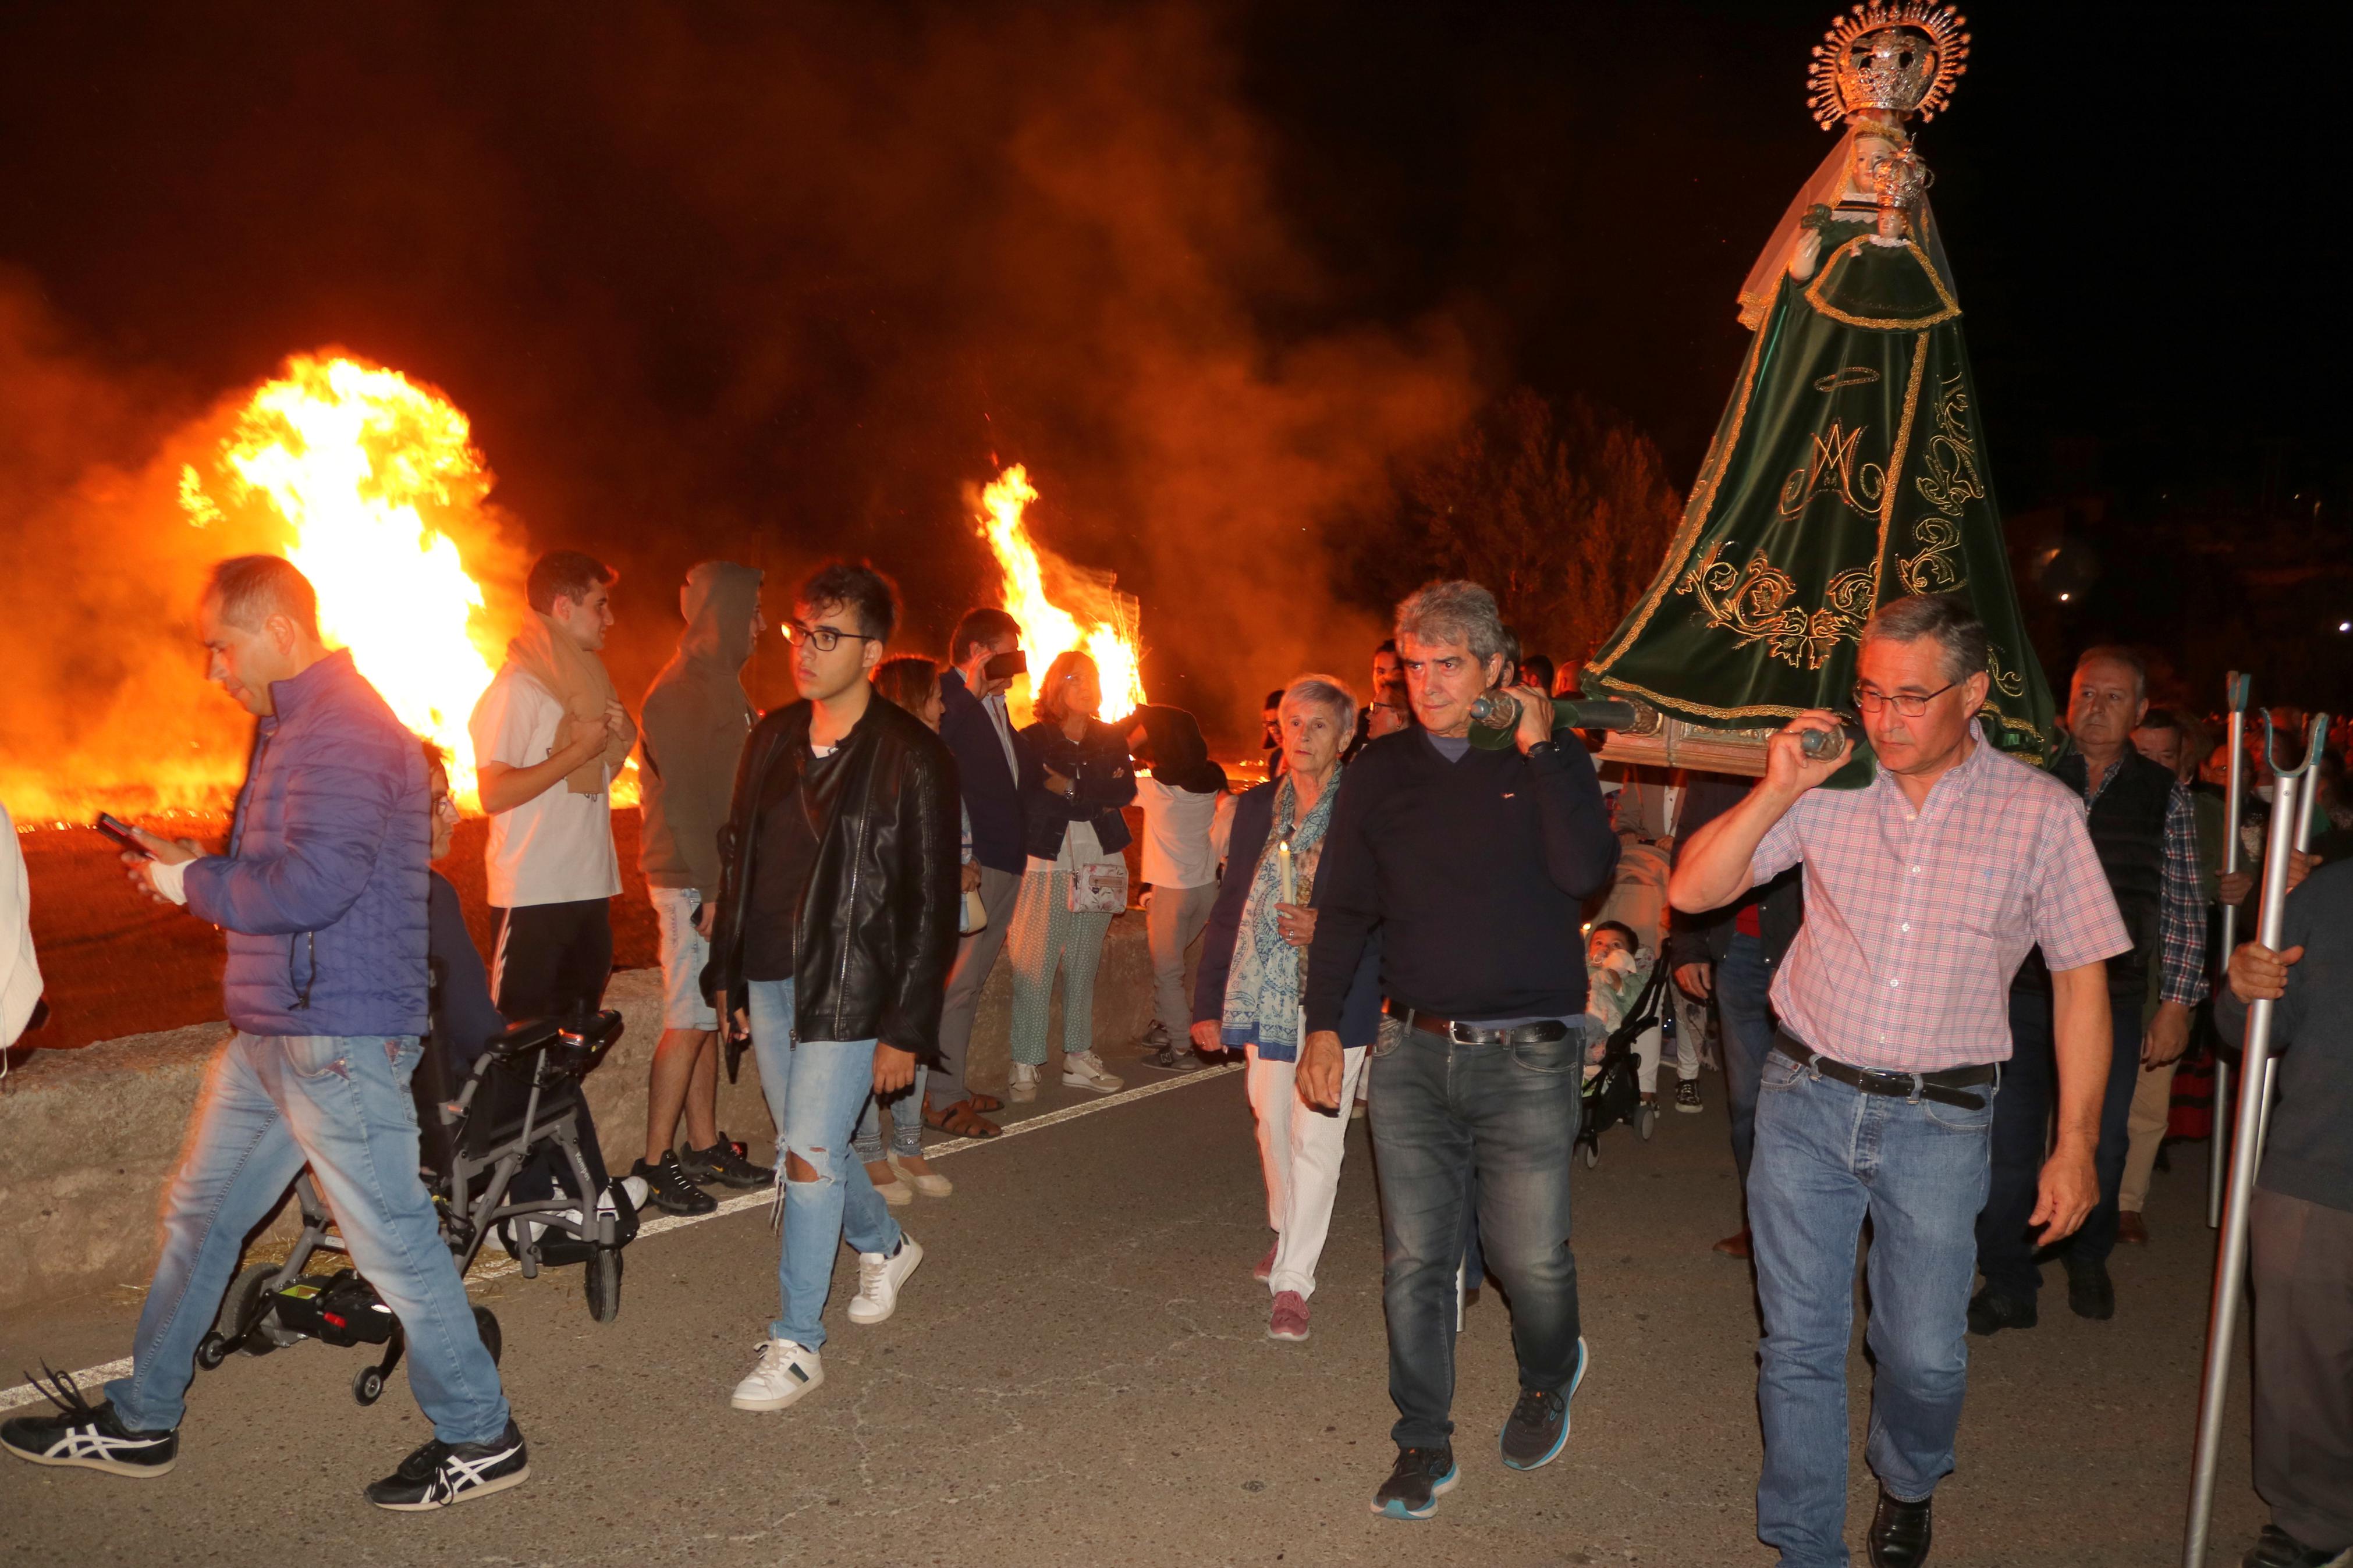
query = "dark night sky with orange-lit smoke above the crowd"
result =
(0, 0, 2353, 742)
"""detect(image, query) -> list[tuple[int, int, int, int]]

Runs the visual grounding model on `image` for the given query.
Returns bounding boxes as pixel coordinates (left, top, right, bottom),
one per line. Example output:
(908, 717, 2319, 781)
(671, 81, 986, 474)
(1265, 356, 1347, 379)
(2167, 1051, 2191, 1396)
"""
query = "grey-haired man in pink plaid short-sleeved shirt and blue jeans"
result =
(1668, 595, 2132, 1568)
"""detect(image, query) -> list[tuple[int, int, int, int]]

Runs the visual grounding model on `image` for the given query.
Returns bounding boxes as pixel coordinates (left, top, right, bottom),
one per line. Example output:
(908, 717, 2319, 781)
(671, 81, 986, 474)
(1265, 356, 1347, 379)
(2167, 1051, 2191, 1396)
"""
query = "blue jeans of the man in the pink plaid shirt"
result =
(1748, 1051, 1995, 1568)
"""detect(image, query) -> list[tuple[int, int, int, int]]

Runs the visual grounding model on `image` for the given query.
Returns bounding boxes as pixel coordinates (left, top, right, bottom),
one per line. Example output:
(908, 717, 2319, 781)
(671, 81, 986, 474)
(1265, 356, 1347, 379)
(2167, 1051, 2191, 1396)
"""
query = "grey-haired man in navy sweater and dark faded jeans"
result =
(1299, 583, 1617, 1519)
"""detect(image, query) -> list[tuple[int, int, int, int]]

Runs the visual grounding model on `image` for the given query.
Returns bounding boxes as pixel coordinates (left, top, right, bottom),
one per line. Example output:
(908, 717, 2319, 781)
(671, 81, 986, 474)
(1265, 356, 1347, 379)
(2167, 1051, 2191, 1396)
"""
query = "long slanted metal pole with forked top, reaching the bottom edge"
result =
(2181, 714, 2320, 1568)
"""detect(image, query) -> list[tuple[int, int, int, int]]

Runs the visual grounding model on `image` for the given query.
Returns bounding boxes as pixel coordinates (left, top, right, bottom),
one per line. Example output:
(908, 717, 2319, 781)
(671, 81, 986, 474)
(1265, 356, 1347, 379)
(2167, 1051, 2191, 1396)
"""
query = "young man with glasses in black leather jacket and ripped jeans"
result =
(704, 564, 963, 1410)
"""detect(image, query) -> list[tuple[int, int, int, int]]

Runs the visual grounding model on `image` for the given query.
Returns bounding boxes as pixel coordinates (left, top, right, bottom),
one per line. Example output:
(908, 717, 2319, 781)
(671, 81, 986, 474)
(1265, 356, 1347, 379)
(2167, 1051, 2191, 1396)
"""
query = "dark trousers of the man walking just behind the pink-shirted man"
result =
(1976, 987, 2141, 1302)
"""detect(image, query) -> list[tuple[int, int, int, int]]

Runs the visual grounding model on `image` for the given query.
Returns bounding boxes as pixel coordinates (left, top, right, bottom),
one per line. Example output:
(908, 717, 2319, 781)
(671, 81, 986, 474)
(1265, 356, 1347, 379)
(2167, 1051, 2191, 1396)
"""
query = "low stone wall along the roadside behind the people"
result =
(0, 915, 1153, 1310)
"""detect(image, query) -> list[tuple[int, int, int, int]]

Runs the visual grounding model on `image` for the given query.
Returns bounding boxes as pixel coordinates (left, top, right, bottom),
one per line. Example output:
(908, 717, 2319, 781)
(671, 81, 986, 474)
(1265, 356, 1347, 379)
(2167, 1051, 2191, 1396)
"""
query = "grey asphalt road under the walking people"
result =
(0, 1053, 2263, 1568)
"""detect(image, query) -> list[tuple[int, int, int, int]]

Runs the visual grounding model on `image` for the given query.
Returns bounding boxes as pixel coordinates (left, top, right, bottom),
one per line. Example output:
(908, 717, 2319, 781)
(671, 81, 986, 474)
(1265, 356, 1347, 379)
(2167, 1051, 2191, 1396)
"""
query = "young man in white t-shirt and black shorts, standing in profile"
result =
(466, 550, 636, 1018)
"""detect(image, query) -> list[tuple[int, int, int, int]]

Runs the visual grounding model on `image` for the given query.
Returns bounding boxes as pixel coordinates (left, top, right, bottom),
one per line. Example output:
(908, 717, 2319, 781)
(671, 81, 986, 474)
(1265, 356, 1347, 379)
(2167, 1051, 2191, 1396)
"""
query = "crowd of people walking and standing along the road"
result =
(0, 550, 2353, 1568)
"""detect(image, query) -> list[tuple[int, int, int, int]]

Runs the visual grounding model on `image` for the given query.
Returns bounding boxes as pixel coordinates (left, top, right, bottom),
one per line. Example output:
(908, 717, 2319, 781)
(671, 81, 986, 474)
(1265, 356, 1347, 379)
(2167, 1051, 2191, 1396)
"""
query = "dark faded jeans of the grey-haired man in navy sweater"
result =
(1367, 1021, 1584, 1448)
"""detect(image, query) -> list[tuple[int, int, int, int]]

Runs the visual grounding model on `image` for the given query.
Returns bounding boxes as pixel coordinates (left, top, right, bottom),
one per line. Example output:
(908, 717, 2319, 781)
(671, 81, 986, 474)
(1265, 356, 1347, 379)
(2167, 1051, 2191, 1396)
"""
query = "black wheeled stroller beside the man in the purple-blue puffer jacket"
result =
(196, 1013, 638, 1406)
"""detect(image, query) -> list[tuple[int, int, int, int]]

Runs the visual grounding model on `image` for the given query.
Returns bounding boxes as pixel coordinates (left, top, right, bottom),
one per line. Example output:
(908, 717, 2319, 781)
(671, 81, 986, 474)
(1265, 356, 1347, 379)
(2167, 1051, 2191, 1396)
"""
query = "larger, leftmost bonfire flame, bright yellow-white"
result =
(179, 355, 499, 806)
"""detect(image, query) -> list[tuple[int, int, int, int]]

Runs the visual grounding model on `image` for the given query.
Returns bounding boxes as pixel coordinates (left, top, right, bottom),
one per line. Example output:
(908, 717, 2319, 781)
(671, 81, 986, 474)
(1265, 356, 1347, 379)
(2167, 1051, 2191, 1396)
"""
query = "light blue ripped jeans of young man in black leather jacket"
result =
(744, 980, 899, 1349)
